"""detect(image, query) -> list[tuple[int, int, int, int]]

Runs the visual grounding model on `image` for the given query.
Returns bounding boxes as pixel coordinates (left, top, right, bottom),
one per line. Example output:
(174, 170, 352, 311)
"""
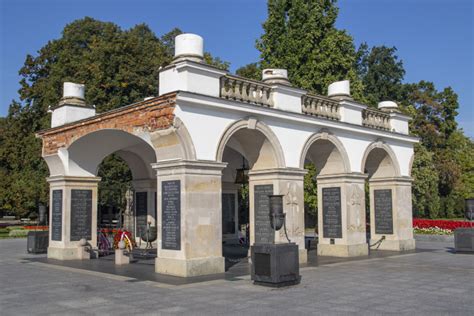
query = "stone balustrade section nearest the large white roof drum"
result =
(220, 75, 272, 107)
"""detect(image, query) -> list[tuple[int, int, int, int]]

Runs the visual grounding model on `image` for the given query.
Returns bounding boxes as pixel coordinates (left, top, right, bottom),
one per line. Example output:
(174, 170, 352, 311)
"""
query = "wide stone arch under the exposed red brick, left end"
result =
(43, 118, 196, 178)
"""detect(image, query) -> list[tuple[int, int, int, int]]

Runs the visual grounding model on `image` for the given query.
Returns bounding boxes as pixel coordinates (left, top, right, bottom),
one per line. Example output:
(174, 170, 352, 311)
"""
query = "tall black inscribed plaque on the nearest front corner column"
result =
(161, 180, 181, 250)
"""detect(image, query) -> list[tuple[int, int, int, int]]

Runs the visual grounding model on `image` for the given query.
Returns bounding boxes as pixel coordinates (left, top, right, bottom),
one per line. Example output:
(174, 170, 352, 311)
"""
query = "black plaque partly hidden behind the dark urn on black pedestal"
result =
(254, 184, 275, 244)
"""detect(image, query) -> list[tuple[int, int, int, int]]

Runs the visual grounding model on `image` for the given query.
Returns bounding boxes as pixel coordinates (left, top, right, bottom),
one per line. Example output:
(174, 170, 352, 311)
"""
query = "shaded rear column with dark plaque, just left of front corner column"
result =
(132, 179, 157, 241)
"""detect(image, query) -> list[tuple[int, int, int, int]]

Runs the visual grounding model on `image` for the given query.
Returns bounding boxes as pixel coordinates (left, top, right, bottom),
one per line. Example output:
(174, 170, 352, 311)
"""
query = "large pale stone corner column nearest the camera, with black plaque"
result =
(153, 160, 226, 277)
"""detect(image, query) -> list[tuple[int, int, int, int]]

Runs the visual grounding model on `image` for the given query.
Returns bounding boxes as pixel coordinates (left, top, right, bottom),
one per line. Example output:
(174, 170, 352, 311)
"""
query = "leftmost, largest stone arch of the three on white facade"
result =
(216, 118, 285, 169)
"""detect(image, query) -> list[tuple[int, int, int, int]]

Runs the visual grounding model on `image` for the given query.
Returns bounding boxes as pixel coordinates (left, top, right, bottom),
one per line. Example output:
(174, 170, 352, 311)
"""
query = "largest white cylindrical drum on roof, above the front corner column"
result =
(174, 33, 204, 62)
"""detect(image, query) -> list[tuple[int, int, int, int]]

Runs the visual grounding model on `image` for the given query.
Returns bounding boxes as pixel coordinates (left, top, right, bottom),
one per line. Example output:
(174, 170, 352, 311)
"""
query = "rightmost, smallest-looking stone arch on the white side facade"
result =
(361, 141, 401, 178)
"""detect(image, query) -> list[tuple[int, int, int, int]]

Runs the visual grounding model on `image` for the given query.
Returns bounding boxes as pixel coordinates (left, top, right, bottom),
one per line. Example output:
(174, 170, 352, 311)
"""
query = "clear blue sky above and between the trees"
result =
(0, 0, 474, 137)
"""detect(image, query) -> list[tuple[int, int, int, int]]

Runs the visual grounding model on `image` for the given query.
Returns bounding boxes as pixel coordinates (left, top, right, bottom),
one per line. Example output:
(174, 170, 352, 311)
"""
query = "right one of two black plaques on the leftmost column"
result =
(71, 190, 92, 241)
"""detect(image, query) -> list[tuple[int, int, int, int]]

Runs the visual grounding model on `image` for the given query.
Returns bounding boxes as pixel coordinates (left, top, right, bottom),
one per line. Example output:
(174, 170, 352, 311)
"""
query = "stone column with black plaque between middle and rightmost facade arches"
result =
(317, 173, 369, 257)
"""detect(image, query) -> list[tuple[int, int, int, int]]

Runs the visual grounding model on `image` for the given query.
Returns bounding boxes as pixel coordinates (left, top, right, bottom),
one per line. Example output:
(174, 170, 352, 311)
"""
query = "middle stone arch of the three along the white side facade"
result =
(300, 131, 351, 173)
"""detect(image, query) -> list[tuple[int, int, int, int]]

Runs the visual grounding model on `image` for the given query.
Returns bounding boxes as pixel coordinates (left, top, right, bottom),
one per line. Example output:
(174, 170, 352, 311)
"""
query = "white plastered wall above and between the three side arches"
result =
(175, 102, 413, 176)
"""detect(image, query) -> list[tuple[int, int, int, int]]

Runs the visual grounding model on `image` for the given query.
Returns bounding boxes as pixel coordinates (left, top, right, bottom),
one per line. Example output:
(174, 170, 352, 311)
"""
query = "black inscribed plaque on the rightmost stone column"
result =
(374, 189, 393, 234)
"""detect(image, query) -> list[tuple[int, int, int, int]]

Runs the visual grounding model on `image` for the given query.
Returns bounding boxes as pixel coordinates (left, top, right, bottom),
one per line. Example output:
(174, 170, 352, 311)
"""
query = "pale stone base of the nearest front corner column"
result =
(155, 257, 225, 277)
